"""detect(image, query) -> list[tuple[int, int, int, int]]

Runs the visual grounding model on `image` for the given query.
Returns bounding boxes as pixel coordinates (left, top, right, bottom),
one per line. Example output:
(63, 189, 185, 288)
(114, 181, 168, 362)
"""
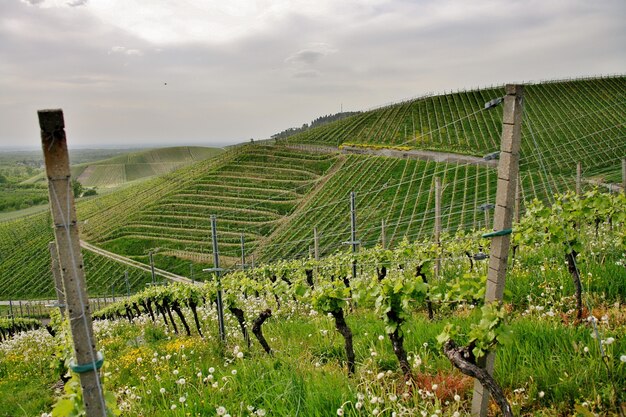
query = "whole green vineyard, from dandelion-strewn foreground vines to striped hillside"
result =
(0, 76, 626, 417)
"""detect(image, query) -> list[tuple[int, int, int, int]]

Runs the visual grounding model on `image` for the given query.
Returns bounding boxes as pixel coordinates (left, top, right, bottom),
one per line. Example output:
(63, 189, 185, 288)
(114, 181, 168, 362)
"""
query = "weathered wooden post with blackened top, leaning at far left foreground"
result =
(38, 110, 107, 417)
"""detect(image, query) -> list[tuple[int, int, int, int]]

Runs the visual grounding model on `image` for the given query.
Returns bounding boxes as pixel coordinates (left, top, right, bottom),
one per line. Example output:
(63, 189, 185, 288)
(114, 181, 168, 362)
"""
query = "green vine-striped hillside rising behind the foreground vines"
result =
(0, 77, 626, 298)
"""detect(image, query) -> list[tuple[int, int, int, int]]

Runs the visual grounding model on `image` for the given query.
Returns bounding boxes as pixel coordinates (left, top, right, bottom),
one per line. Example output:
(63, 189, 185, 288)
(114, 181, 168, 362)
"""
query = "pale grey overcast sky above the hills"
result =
(0, 0, 626, 149)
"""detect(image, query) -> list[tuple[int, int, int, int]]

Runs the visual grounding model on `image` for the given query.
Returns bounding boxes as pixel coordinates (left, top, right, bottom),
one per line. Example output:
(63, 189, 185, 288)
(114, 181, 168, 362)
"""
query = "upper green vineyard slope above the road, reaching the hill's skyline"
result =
(287, 76, 626, 176)
